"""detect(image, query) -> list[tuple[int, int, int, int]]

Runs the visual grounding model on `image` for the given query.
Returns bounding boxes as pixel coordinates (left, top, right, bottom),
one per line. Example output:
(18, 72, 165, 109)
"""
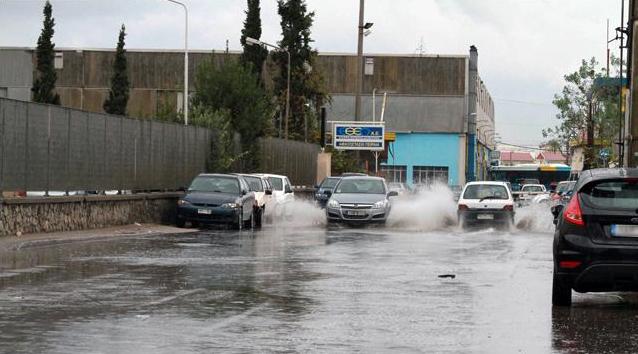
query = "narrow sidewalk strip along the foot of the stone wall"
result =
(0, 224, 197, 252)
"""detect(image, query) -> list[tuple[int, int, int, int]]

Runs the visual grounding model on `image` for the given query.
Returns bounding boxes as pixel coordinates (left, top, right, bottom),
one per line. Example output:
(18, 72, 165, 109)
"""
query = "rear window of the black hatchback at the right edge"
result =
(580, 179, 638, 210)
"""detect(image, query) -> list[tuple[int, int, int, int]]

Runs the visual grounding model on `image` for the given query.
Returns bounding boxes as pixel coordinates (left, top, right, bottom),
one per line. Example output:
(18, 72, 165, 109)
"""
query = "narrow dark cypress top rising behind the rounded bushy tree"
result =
(241, 0, 268, 82)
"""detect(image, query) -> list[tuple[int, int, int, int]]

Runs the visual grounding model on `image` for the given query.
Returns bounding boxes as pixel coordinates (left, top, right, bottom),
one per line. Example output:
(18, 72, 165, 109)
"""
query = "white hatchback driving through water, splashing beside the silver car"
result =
(457, 182, 515, 228)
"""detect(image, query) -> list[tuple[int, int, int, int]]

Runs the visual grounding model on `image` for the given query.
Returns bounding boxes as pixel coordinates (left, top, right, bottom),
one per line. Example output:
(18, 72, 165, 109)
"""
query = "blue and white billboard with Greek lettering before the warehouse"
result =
(333, 122, 385, 151)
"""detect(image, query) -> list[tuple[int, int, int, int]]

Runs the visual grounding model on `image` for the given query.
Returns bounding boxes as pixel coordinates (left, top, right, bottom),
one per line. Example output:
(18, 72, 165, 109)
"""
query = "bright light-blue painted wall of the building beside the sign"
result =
(384, 133, 465, 185)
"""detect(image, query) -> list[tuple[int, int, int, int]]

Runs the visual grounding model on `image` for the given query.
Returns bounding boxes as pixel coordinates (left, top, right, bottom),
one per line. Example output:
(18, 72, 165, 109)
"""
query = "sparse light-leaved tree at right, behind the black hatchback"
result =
(543, 58, 620, 167)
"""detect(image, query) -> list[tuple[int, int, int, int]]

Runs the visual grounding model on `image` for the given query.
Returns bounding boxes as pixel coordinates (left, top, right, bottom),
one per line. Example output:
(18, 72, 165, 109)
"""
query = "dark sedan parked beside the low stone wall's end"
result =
(177, 174, 256, 230)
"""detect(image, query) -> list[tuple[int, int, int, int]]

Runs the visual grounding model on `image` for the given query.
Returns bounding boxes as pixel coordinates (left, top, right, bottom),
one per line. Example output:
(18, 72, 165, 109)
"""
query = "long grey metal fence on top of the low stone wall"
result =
(0, 98, 212, 191)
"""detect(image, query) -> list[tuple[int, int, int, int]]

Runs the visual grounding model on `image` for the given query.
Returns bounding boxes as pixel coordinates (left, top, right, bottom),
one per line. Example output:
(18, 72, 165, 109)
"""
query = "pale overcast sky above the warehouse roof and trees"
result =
(0, 0, 632, 145)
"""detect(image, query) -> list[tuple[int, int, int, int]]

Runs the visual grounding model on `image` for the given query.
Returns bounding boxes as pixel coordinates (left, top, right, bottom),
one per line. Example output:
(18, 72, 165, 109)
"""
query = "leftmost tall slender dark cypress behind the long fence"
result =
(31, 1, 60, 105)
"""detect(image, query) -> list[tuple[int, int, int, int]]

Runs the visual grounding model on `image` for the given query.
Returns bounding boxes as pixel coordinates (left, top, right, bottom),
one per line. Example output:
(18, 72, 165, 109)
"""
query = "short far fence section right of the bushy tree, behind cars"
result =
(259, 138, 321, 186)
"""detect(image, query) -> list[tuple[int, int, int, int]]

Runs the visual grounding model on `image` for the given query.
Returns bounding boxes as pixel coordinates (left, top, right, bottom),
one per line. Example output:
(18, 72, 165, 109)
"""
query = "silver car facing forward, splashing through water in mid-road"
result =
(326, 176, 398, 224)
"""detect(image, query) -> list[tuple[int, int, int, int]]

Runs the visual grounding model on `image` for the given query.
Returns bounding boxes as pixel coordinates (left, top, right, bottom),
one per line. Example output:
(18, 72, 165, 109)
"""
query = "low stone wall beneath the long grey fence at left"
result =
(0, 193, 181, 236)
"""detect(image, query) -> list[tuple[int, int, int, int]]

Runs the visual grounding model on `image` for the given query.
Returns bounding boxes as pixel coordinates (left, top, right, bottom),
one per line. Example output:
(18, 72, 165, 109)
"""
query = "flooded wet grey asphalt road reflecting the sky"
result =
(0, 223, 638, 353)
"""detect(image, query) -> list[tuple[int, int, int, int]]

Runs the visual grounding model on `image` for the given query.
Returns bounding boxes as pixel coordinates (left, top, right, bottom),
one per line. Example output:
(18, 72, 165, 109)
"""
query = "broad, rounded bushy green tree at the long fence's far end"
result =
(192, 58, 273, 171)
